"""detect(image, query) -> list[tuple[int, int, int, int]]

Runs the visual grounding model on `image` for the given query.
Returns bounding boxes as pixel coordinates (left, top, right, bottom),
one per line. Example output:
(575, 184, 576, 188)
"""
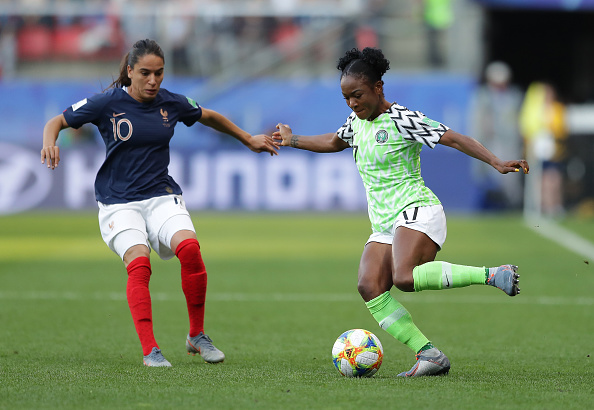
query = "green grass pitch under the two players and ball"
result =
(0, 213, 594, 409)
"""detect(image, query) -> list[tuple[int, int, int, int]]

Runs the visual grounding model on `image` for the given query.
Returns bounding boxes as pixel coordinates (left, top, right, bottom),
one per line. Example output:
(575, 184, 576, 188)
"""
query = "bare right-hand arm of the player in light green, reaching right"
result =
(439, 130, 530, 174)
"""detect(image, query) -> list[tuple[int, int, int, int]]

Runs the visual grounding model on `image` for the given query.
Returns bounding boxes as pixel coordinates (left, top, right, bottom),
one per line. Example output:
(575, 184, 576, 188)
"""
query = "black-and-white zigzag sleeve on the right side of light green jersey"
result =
(389, 104, 449, 148)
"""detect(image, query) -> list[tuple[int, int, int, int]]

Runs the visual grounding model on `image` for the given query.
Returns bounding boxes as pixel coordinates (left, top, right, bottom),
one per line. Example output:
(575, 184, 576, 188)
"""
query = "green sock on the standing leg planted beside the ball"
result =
(365, 292, 429, 353)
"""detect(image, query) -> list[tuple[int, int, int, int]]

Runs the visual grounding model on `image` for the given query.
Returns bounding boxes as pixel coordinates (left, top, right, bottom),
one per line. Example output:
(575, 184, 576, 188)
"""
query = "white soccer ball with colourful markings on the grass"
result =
(332, 329, 384, 377)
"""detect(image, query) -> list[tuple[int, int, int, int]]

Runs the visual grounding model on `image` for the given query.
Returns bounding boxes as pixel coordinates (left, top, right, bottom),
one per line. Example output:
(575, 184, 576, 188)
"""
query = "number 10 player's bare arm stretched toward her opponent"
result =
(199, 108, 278, 155)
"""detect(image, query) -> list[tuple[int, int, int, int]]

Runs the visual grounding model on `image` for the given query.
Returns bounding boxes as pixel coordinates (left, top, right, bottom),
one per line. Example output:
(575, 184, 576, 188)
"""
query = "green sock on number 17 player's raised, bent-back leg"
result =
(413, 262, 488, 292)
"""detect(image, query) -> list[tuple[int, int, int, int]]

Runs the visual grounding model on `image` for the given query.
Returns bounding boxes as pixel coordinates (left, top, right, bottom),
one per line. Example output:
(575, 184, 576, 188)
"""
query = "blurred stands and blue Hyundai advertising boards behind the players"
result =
(0, 0, 594, 214)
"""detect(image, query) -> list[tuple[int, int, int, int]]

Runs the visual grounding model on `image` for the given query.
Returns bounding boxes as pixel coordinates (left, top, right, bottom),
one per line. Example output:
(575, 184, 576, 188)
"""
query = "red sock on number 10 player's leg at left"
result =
(126, 256, 159, 356)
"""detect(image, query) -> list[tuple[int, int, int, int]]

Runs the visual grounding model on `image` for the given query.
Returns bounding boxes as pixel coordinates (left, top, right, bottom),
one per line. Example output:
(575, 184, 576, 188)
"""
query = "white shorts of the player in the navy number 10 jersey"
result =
(98, 195, 196, 259)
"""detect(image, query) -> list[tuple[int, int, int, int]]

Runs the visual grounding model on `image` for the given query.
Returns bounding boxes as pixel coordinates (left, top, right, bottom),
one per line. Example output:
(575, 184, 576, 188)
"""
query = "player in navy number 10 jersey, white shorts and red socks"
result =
(41, 39, 277, 367)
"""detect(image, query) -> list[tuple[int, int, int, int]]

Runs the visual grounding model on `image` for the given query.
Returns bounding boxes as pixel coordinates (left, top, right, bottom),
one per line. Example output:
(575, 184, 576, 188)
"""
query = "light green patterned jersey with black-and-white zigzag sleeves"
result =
(337, 103, 449, 235)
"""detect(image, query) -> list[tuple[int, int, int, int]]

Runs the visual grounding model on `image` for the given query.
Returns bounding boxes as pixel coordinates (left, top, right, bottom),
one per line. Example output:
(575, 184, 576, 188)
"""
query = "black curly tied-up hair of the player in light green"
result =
(336, 47, 390, 84)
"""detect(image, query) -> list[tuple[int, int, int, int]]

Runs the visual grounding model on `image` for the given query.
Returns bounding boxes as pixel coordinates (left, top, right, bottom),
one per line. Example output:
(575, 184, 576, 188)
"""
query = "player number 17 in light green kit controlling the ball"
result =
(273, 48, 529, 377)
